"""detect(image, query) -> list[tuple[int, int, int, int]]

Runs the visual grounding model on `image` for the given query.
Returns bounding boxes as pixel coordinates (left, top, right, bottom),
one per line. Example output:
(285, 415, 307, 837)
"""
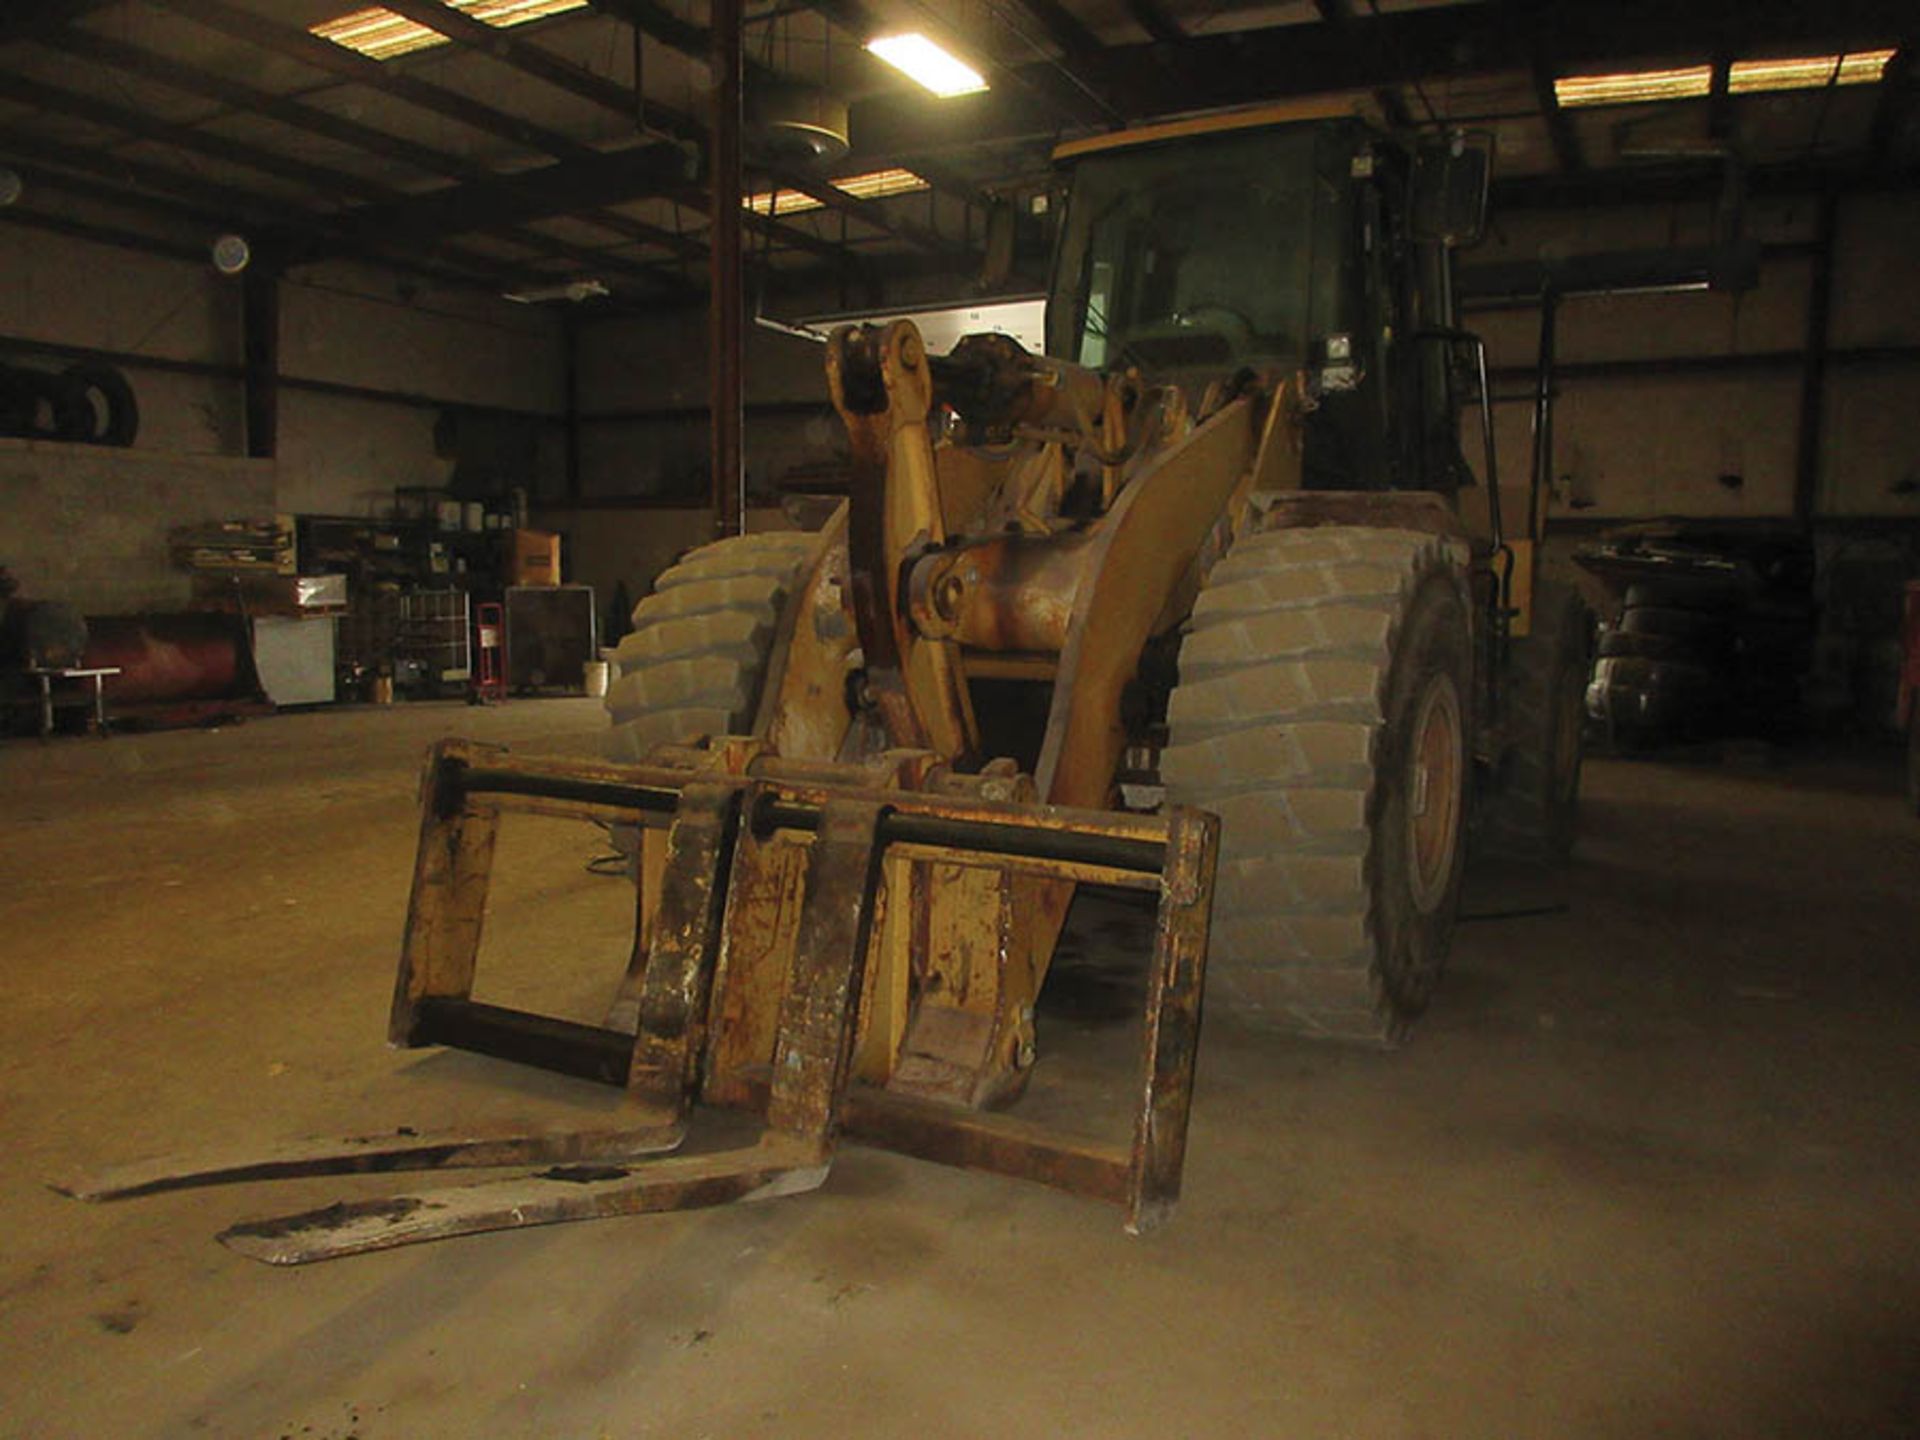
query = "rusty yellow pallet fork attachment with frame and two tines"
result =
(71, 739, 1219, 1265)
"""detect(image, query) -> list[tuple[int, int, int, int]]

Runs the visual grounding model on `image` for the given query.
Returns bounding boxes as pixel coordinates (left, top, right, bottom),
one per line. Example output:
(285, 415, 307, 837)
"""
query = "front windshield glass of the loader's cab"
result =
(1046, 127, 1315, 372)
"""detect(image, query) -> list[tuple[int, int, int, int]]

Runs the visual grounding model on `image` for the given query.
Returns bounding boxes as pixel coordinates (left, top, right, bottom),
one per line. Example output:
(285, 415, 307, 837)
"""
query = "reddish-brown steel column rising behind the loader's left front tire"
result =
(707, 0, 747, 536)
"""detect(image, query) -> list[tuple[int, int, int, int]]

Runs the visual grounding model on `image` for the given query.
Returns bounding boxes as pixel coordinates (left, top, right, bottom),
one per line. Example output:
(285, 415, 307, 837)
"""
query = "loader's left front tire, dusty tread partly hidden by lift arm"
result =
(607, 530, 818, 760)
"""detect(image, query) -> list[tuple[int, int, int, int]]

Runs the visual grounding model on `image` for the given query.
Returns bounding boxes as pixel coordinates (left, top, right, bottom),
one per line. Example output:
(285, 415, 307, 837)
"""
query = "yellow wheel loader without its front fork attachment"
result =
(609, 115, 1584, 1052)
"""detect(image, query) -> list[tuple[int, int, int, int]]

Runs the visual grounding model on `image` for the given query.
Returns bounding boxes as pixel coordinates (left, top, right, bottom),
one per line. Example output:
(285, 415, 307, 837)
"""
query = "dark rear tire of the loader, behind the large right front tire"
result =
(1478, 580, 1594, 866)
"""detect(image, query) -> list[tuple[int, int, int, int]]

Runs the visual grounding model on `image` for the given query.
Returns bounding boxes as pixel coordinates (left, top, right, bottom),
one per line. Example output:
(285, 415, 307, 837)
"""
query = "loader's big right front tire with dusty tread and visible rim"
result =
(1160, 526, 1473, 1044)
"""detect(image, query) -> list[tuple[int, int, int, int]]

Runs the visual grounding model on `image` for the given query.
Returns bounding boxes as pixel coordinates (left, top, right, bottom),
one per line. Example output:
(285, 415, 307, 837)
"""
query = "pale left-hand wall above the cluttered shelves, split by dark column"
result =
(0, 223, 566, 552)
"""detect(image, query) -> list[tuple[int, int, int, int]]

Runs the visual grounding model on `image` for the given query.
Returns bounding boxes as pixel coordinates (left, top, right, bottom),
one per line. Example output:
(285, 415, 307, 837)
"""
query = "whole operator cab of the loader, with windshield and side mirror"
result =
(1046, 119, 1486, 510)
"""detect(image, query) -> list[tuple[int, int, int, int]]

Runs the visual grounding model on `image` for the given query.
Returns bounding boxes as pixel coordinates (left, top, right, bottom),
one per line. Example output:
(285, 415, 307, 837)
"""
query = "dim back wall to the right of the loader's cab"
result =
(1467, 194, 1920, 522)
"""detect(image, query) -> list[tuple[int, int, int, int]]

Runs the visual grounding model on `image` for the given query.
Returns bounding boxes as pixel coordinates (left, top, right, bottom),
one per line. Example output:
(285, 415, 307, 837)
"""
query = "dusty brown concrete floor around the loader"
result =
(0, 701, 1920, 1440)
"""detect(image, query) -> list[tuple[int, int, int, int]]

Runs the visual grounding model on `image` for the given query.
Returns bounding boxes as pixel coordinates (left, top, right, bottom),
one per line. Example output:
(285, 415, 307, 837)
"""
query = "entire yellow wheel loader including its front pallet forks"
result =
(69, 113, 1586, 1263)
